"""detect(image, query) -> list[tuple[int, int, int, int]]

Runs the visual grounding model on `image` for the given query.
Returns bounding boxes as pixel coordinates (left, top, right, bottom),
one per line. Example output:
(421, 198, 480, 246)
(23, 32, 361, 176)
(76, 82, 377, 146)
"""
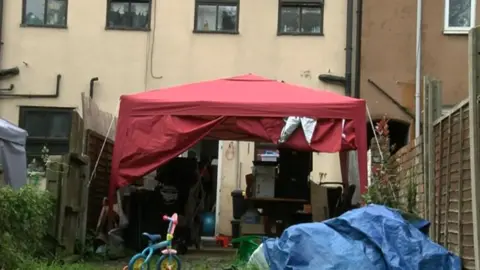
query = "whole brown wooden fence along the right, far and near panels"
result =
(390, 77, 478, 269)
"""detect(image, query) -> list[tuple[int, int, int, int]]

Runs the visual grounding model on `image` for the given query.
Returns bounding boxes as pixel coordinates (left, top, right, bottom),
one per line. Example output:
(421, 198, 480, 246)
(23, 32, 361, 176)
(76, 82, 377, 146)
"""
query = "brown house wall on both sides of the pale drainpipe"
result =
(360, 0, 480, 122)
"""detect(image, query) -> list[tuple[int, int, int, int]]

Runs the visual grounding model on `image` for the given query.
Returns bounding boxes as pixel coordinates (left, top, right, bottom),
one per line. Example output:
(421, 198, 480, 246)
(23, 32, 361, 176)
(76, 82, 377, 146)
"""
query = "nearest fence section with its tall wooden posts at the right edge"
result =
(416, 26, 480, 269)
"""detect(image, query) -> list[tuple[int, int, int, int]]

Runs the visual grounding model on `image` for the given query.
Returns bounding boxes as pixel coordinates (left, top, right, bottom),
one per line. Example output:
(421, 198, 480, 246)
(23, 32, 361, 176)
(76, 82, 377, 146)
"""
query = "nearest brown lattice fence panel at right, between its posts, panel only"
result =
(432, 101, 475, 269)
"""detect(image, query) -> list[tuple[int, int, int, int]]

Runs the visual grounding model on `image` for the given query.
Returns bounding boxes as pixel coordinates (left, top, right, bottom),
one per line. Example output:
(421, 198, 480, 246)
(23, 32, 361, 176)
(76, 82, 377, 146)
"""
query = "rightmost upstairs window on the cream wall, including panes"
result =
(278, 0, 323, 35)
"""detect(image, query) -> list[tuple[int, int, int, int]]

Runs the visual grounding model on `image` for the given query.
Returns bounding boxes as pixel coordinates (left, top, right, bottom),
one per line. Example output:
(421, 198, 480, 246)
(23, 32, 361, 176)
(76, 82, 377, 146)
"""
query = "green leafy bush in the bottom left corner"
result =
(0, 186, 54, 269)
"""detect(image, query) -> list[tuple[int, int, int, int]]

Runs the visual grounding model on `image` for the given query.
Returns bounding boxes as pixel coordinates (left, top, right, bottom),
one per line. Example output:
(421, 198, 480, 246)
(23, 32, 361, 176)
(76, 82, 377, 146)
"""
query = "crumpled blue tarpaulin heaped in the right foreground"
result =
(263, 205, 461, 270)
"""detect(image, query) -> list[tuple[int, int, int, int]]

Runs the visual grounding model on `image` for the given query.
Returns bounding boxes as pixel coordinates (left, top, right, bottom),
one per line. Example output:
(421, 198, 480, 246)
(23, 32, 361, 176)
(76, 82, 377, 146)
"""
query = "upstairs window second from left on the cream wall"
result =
(107, 0, 151, 30)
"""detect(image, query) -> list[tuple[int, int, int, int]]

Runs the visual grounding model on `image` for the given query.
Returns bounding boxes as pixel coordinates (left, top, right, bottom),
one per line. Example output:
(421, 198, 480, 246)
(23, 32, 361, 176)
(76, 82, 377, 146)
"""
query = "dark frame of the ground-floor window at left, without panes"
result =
(18, 106, 74, 157)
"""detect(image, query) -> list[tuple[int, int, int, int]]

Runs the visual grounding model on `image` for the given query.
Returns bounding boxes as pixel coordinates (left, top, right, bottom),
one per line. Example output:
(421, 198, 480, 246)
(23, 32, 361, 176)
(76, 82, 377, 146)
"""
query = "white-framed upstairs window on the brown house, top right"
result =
(444, 0, 477, 34)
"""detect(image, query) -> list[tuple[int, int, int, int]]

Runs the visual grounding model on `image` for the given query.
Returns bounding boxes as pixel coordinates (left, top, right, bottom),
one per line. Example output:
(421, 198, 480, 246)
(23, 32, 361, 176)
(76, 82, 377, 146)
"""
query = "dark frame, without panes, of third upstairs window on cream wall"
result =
(193, 0, 240, 35)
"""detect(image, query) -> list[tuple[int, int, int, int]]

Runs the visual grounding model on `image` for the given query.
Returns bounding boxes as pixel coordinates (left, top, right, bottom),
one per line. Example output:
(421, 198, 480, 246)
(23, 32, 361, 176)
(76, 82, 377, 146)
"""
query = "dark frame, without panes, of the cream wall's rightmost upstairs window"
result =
(277, 0, 325, 36)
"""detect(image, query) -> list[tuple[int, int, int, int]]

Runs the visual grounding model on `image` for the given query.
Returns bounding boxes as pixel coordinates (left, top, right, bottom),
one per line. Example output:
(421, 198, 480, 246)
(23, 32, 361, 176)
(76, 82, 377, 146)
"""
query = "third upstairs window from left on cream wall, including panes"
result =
(194, 0, 239, 33)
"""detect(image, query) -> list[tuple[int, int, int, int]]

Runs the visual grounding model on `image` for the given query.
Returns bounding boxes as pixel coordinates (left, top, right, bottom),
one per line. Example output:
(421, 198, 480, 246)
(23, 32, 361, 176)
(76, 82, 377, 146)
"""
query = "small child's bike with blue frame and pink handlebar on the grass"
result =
(123, 214, 181, 270)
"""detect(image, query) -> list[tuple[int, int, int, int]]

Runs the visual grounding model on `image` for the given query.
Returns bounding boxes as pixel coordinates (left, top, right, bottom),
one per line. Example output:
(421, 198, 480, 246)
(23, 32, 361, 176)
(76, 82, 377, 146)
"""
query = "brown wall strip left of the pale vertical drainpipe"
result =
(360, 0, 416, 121)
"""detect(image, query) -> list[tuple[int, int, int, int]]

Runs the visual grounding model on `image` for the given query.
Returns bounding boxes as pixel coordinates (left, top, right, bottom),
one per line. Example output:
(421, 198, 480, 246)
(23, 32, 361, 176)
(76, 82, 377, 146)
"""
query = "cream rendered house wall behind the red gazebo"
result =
(0, 0, 346, 234)
